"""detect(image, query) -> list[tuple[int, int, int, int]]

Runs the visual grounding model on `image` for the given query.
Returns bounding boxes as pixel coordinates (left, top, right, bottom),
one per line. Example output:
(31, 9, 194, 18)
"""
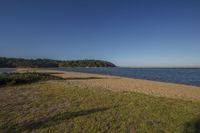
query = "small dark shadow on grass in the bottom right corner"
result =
(183, 119, 200, 133)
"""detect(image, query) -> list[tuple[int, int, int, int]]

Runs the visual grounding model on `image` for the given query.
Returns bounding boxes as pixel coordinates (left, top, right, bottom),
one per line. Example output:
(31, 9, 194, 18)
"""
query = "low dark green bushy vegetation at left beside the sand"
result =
(0, 73, 61, 86)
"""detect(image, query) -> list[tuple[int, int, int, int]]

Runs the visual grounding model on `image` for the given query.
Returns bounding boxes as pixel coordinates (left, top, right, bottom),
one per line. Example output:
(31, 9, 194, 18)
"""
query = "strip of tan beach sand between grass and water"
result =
(17, 69, 200, 100)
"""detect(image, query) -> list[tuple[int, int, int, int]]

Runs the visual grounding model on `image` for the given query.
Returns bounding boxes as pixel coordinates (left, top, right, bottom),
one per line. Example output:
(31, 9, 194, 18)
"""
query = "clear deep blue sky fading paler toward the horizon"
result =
(0, 0, 200, 66)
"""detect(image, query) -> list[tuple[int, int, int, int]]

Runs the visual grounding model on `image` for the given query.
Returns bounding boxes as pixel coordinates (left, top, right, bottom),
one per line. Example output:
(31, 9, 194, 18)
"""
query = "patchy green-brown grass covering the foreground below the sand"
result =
(0, 80, 200, 133)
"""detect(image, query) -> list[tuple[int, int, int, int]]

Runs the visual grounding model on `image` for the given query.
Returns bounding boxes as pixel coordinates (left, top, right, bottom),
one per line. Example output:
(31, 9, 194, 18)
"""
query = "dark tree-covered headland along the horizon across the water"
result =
(0, 57, 115, 68)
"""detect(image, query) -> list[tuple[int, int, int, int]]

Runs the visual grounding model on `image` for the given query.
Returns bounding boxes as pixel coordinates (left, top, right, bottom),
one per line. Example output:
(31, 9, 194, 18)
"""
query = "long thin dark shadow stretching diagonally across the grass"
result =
(4, 108, 111, 132)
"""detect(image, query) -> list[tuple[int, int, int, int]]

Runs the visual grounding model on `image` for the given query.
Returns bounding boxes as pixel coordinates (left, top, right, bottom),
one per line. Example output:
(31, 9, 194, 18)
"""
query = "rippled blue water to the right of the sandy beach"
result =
(50, 68, 200, 86)
